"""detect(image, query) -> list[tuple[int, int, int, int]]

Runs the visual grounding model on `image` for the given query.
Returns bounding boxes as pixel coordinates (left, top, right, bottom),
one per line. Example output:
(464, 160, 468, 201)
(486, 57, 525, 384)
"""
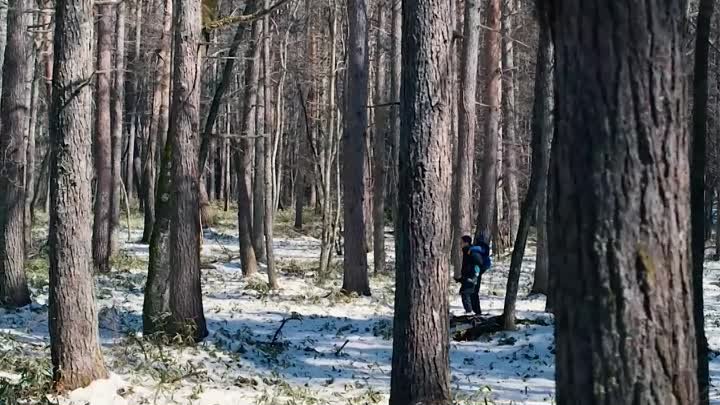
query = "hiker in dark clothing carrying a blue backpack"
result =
(455, 235, 485, 315)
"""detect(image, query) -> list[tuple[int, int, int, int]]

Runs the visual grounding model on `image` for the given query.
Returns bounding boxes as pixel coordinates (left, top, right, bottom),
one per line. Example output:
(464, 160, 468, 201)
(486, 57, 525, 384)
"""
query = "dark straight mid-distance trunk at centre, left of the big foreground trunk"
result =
(342, 0, 370, 295)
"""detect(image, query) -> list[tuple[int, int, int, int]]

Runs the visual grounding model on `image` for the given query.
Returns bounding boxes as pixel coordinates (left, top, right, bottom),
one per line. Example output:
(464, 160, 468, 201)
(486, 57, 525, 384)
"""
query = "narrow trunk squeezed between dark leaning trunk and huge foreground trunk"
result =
(530, 3, 555, 295)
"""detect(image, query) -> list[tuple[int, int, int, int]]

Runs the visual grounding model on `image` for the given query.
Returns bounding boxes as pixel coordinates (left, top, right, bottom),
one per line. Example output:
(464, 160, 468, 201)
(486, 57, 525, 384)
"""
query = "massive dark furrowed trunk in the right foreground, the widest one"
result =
(549, 0, 698, 405)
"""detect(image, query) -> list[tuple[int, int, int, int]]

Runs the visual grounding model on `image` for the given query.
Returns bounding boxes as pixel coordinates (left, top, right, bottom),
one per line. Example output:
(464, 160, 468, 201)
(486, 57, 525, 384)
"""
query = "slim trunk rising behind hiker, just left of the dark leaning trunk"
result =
(502, 0, 516, 242)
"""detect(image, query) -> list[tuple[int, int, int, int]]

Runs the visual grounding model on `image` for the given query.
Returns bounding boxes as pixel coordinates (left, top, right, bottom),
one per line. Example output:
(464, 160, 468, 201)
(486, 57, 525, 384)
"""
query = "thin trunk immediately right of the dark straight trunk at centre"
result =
(372, 4, 389, 273)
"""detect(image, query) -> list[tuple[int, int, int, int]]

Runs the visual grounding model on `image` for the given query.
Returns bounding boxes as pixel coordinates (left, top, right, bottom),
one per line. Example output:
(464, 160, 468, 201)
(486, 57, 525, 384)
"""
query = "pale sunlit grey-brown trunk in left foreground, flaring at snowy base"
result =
(48, 0, 107, 391)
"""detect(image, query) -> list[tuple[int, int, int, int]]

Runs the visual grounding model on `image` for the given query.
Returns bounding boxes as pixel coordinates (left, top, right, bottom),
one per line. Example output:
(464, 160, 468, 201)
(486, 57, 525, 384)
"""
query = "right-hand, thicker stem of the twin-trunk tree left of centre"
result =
(168, 0, 208, 340)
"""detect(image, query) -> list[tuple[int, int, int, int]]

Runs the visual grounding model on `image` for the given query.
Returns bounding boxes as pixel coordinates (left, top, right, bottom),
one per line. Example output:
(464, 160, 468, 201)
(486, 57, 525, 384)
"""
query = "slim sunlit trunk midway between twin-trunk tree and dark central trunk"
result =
(261, 0, 280, 289)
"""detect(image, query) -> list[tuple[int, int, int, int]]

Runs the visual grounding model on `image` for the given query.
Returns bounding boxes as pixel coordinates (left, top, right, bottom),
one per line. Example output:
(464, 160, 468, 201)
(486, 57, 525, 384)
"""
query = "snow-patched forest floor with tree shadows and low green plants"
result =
(0, 207, 720, 405)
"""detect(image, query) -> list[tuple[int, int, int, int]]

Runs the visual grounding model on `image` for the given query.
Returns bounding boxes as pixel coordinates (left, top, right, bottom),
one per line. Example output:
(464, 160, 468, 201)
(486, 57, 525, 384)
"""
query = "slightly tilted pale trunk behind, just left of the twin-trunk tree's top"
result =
(142, 0, 173, 243)
